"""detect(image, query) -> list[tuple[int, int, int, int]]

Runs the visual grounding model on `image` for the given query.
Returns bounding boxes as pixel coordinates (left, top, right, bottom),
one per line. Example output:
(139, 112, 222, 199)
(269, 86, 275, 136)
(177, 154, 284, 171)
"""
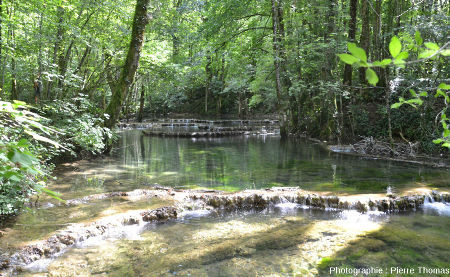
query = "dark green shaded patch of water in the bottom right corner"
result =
(318, 213, 450, 276)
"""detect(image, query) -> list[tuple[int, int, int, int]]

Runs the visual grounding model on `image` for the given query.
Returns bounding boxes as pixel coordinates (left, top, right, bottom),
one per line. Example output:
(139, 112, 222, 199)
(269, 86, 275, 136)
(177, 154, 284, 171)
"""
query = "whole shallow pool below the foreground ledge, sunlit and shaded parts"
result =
(19, 208, 450, 276)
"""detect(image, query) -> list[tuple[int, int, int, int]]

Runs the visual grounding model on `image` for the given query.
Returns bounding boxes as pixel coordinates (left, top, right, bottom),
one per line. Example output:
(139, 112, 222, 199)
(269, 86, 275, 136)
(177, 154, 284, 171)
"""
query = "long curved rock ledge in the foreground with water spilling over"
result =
(0, 185, 450, 276)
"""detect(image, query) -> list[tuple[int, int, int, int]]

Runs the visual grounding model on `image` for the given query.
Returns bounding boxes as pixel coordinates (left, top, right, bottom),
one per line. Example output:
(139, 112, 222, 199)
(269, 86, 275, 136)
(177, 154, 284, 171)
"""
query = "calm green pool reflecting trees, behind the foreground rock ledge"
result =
(52, 130, 450, 199)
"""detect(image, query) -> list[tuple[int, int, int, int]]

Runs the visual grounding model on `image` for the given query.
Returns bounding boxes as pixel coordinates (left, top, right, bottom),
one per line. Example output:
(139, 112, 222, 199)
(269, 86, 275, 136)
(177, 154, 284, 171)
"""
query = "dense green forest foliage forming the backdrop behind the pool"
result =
(0, 0, 449, 156)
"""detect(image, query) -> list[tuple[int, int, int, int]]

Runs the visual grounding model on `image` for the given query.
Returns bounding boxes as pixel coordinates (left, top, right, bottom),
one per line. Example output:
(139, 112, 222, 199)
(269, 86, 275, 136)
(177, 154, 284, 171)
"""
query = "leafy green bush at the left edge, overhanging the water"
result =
(0, 101, 61, 217)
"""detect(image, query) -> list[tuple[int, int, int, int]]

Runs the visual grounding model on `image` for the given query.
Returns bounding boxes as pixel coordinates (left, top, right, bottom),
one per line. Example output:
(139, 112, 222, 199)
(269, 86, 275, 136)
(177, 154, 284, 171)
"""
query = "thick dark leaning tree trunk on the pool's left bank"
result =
(105, 0, 150, 128)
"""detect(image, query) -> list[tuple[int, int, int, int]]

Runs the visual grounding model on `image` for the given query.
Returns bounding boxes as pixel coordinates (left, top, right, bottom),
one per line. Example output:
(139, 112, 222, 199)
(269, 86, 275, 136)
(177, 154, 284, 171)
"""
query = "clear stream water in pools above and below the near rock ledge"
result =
(0, 130, 450, 276)
